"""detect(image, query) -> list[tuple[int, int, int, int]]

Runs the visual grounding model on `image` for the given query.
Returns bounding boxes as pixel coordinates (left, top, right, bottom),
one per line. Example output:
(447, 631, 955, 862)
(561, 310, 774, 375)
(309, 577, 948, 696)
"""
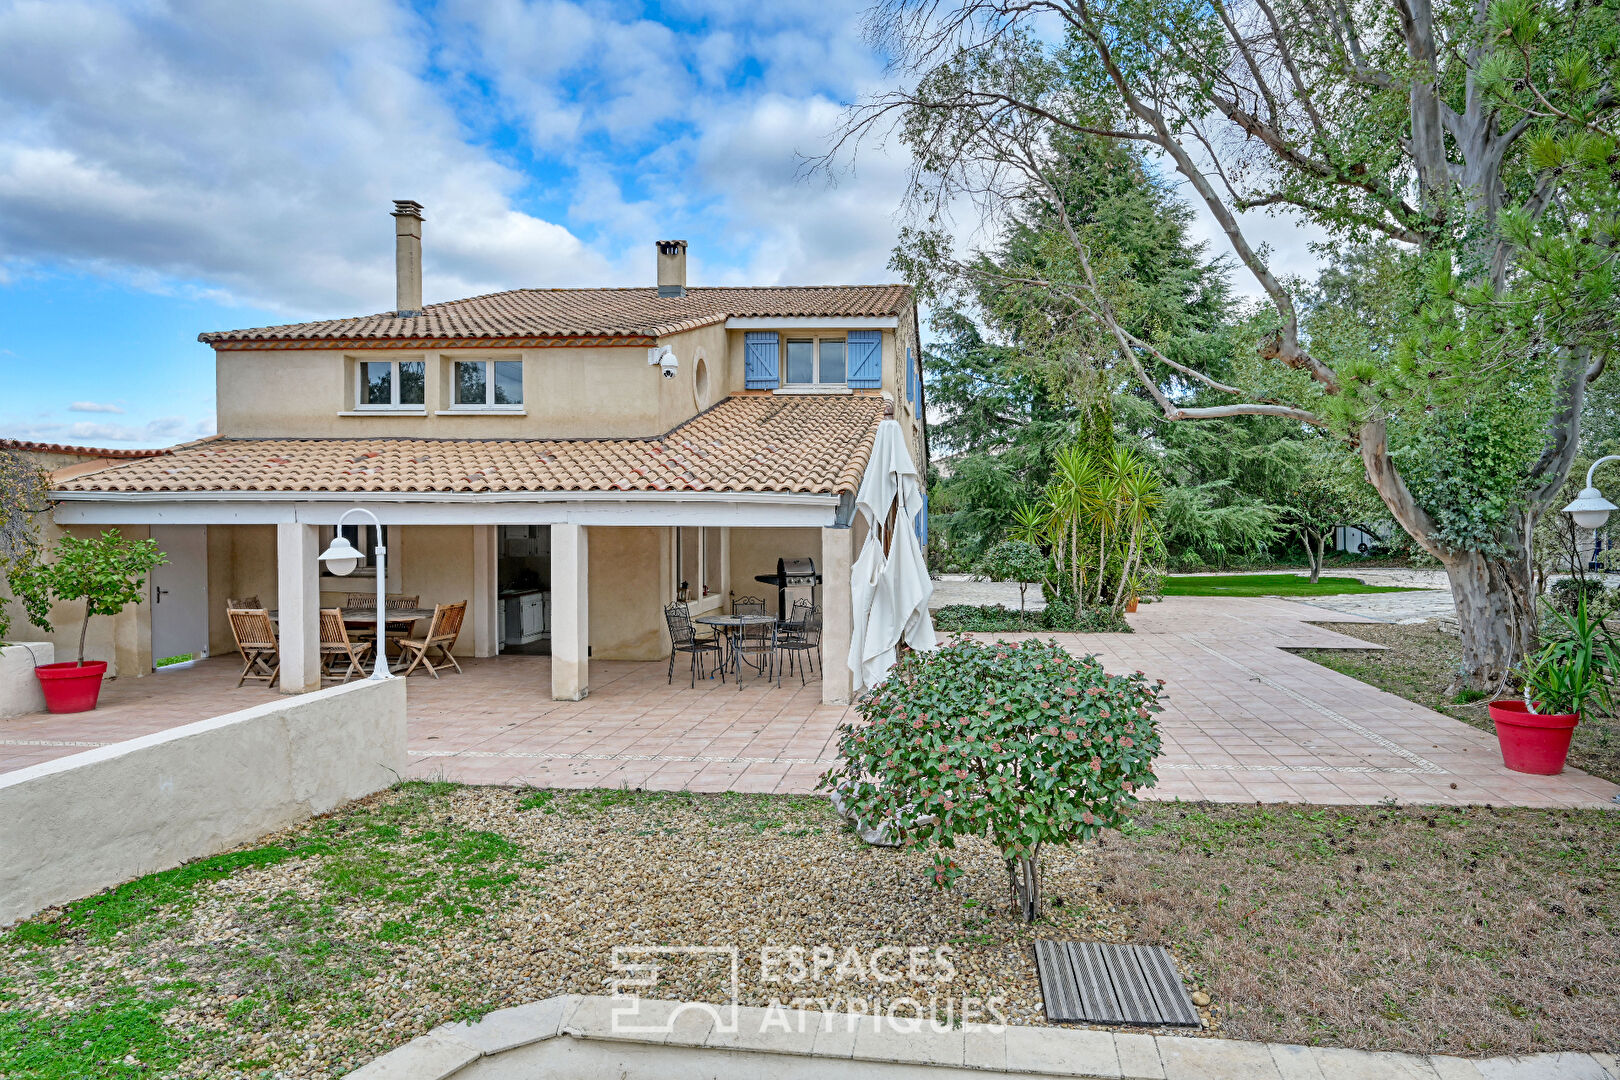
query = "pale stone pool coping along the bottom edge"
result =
(347, 994, 1620, 1080)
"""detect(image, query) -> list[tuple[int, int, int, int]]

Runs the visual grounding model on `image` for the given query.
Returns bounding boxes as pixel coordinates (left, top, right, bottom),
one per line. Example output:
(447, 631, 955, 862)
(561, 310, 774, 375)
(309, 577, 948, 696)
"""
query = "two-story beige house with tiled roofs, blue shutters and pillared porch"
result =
(52, 202, 927, 701)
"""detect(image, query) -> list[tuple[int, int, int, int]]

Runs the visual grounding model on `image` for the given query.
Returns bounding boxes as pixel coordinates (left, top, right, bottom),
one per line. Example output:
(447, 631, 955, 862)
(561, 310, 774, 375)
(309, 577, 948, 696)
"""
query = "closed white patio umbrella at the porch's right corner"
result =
(849, 419, 938, 690)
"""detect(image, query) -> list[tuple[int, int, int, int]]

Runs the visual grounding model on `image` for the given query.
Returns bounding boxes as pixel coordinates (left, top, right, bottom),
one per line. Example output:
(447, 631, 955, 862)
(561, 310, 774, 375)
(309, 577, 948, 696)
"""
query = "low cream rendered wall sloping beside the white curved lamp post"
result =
(0, 675, 407, 926)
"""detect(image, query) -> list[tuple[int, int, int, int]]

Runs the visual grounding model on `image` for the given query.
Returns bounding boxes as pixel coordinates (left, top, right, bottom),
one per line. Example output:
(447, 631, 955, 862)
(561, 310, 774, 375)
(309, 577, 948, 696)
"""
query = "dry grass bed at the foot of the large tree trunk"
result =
(1294, 622, 1620, 784)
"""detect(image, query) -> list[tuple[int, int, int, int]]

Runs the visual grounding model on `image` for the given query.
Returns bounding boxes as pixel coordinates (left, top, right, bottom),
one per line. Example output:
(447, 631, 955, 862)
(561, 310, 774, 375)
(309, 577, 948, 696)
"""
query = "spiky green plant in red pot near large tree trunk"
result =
(1490, 594, 1615, 776)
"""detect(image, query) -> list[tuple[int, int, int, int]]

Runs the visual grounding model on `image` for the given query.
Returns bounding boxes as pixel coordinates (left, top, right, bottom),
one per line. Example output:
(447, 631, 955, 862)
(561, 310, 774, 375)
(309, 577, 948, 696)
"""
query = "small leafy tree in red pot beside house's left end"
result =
(8, 529, 164, 712)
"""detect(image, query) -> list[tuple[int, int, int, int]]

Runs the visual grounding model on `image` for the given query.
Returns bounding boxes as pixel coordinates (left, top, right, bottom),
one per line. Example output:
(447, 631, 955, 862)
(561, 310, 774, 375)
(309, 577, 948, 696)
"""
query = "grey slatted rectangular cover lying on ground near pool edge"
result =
(1035, 941, 1199, 1027)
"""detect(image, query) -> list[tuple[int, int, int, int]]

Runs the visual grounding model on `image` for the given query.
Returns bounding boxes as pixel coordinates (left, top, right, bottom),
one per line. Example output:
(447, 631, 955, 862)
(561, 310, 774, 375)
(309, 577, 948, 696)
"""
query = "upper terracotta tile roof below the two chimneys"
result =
(198, 285, 910, 345)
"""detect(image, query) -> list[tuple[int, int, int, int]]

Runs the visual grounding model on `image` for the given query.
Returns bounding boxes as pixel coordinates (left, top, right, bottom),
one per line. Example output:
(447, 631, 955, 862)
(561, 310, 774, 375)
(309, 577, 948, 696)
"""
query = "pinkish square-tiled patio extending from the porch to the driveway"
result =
(0, 597, 1620, 806)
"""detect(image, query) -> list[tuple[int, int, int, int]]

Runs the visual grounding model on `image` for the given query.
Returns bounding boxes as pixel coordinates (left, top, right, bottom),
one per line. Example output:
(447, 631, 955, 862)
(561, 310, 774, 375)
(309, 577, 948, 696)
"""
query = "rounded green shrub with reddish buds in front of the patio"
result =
(821, 638, 1165, 921)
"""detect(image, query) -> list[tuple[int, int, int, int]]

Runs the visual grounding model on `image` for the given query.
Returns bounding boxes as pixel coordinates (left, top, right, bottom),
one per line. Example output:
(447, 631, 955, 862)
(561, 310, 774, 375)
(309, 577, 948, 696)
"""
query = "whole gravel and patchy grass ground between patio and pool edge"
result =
(0, 784, 1620, 1080)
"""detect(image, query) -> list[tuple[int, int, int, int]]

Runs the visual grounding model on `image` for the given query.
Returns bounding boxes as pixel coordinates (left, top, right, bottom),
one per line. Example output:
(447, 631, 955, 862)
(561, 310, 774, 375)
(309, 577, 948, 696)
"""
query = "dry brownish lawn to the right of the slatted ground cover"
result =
(1098, 805, 1620, 1054)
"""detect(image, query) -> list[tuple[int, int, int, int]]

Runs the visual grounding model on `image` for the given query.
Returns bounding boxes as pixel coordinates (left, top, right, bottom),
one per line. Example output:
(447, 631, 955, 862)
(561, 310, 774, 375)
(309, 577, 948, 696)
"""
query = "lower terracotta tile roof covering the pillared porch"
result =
(55, 393, 883, 494)
